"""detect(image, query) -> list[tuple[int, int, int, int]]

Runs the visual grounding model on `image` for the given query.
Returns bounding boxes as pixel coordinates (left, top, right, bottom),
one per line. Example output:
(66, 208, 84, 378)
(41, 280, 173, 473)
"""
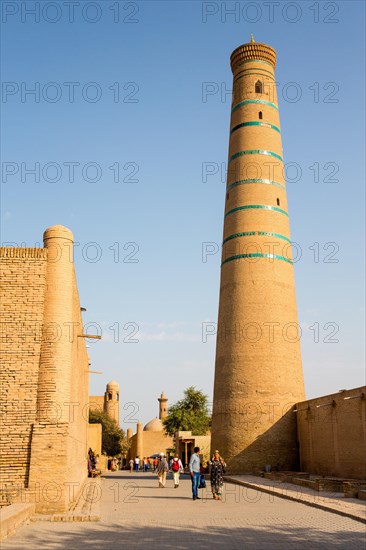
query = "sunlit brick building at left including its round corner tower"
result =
(0, 226, 89, 512)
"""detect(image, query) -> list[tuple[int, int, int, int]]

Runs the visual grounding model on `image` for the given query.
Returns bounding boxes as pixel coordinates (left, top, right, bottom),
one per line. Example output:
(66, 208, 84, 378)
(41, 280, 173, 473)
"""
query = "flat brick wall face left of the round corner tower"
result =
(0, 248, 47, 487)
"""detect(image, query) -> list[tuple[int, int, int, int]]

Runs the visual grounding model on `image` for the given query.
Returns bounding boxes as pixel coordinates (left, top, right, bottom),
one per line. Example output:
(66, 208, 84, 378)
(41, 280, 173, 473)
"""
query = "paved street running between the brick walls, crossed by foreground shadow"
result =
(1, 472, 365, 550)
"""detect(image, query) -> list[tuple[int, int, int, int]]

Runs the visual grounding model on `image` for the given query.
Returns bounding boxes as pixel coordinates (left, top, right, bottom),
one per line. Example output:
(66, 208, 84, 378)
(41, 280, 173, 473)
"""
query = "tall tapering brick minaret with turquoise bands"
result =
(212, 36, 304, 473)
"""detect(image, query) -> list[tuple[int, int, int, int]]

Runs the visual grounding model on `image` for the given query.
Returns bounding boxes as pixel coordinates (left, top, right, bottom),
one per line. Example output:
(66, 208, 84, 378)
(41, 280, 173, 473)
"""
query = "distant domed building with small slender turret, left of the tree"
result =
(127, 392, 174, 466)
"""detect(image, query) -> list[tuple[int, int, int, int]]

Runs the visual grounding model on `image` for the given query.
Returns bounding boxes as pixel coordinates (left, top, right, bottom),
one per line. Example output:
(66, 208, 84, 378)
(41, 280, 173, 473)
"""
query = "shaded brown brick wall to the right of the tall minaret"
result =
(295, 386, 366, 479)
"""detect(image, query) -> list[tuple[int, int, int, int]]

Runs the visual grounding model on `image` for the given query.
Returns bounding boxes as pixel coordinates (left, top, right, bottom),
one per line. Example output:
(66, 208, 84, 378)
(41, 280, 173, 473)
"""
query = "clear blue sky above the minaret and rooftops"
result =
(1, 0, 365, 427)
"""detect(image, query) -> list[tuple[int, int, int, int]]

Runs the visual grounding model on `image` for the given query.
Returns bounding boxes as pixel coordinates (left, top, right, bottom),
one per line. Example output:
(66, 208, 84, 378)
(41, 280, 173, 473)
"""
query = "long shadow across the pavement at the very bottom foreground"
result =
(1, 520, 365, 550)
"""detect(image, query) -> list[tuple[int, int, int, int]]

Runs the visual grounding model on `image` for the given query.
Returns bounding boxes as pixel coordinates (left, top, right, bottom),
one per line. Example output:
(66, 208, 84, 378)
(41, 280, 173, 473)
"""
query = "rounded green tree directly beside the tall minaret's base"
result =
(162, 386, 211, 436)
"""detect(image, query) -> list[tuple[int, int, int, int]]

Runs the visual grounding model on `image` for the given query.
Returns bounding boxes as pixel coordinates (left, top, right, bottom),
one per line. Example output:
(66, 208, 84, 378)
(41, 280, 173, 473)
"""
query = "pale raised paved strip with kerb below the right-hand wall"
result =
(225, 475, 366, 523)
